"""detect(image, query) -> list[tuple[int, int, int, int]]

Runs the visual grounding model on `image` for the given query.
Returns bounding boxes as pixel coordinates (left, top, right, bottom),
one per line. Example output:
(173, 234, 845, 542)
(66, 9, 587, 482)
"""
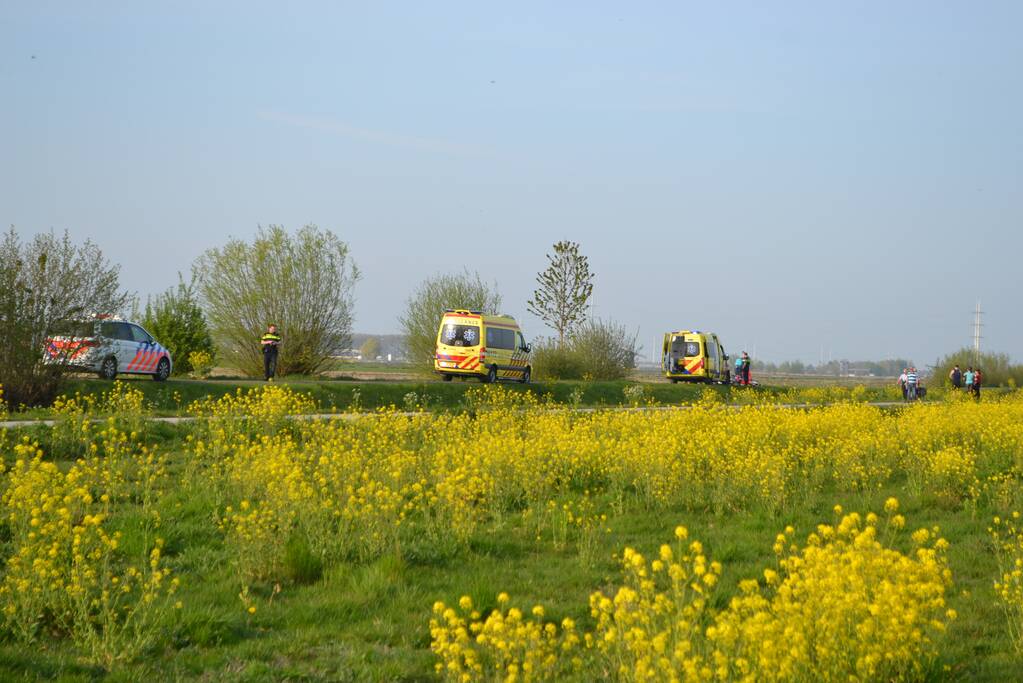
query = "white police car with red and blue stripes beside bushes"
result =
(45, 316, 174, 381)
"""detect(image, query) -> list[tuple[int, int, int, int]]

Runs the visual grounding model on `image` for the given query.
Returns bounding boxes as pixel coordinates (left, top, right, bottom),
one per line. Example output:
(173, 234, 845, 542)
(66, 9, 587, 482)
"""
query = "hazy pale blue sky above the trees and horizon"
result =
(0, 2, 1023, 364)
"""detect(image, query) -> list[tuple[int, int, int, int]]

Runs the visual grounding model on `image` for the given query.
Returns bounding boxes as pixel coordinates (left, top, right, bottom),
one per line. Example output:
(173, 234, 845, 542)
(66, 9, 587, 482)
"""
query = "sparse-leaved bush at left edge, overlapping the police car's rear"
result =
(0, 227, 130, 407)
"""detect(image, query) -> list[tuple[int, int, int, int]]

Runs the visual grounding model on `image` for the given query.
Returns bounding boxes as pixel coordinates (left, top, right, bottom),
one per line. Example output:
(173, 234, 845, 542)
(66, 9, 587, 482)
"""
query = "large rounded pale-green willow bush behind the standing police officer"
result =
(193, 225, 360, 376)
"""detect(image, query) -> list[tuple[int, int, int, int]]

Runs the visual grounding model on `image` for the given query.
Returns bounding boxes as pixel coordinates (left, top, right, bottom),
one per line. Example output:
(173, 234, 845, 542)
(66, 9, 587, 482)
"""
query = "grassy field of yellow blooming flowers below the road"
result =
(0, 383, 1023, 681)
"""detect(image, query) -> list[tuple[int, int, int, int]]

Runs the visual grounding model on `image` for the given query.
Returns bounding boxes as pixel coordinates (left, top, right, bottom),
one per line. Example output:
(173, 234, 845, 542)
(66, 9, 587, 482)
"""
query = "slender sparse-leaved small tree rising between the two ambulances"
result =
(528, 241, 593, 345)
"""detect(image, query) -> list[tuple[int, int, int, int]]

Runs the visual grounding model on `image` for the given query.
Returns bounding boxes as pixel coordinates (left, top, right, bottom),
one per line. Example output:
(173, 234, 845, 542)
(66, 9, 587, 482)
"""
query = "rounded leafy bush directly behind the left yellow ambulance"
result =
(398, 270, 501, 368)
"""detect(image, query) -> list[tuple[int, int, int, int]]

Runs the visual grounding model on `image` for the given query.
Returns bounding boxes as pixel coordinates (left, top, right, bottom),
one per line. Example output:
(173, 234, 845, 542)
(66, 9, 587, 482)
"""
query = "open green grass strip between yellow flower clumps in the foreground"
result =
(0, 425, 1023, 681)
